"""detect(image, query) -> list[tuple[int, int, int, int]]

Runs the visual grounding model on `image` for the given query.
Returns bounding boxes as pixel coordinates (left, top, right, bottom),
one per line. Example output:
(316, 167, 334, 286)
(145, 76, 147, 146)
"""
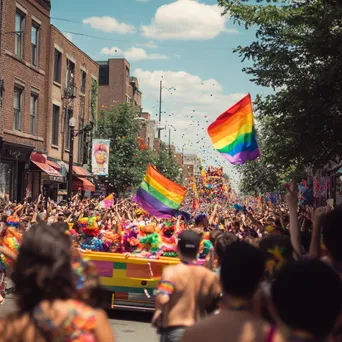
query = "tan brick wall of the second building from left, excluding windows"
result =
(45, 26, 99, 164)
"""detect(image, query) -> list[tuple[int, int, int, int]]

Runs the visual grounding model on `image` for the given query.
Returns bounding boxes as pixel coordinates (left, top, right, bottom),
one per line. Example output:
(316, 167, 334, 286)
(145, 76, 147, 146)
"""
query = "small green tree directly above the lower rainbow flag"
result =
(156, 143, 182, 183)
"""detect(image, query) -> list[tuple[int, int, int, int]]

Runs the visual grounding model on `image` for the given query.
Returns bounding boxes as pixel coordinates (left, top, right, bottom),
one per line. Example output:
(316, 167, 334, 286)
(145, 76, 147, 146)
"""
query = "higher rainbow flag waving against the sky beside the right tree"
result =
(208, 94, 260, 164)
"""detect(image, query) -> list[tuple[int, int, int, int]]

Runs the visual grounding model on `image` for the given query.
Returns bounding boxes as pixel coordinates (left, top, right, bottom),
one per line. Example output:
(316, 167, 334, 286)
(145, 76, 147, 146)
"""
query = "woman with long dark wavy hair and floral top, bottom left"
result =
(0, 224, 114, 342)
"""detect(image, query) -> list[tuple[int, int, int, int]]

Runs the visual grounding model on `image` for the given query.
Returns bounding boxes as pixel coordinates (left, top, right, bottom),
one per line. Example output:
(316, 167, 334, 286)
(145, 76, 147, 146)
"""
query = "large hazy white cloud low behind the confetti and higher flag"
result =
(134, 68, 246, 173)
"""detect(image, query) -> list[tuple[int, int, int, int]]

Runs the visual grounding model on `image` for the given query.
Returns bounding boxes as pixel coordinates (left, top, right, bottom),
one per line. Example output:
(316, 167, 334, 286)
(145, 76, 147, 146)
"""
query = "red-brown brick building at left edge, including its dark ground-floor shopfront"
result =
(0, 0, 51, 200)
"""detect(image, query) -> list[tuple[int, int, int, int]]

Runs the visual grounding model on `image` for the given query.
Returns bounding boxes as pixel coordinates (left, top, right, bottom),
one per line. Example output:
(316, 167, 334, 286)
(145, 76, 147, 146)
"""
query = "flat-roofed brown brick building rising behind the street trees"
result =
(97, 58, 142, 110)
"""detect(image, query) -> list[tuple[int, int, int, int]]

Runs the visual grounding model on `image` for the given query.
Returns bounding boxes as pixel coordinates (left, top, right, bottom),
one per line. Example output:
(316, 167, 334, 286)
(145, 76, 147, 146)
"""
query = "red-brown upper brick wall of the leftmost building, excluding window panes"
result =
(3, 0, 50, 150)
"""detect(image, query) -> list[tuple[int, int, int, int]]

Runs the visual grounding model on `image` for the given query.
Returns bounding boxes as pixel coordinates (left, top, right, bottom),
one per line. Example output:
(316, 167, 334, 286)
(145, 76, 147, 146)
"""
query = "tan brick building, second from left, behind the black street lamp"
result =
(45, 26, 99, 197)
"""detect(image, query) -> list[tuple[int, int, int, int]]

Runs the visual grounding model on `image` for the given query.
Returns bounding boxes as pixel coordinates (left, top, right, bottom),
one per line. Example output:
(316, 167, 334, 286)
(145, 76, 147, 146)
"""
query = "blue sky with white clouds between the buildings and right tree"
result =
(51, 0, 267, 176)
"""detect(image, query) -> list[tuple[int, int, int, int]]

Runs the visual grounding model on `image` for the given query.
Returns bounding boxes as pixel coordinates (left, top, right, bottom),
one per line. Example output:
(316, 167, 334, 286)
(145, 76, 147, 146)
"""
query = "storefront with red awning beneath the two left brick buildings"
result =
(27, 152, 65, 201)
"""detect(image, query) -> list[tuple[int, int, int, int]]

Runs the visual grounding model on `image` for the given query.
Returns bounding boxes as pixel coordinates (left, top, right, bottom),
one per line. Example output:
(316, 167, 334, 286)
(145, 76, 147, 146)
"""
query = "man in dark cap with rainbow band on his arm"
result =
(152, 230, 220, 342)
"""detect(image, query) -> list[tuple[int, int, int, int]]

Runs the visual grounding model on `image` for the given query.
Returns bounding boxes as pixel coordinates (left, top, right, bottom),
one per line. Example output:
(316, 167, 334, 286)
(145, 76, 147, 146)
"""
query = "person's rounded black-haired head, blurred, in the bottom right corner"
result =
(268, 259, 342, 342)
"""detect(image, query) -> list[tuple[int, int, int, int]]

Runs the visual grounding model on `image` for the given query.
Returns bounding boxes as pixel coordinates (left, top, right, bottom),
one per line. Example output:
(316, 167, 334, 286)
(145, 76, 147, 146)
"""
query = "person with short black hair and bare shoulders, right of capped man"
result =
(182, 241, 269, 342)
